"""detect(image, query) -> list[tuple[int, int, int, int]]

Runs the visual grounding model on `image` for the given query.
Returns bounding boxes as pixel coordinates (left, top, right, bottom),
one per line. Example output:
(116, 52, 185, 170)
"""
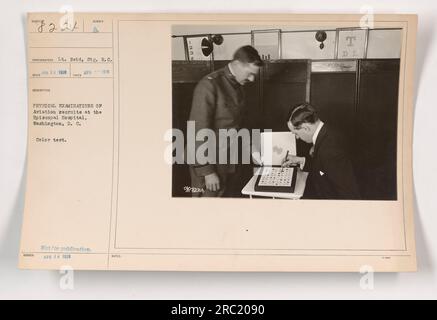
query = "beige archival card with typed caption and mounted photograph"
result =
(19, 12, 417, 272)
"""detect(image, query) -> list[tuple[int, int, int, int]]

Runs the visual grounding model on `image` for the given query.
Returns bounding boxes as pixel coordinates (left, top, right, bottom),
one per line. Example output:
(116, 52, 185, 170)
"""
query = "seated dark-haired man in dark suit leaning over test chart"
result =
(283, 103, 360, 199)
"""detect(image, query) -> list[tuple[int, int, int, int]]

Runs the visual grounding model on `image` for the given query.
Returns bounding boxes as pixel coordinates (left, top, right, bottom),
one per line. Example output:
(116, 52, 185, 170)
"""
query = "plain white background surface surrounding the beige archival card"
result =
(0, 0, 437, 299)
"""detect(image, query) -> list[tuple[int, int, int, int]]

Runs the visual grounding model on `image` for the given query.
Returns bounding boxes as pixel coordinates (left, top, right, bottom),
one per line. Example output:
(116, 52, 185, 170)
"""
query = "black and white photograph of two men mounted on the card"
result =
(171, 25, 403, 201)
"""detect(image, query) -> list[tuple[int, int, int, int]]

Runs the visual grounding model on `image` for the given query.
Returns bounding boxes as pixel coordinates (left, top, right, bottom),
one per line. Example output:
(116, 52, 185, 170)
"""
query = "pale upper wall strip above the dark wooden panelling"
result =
(172, 25, 401, 60)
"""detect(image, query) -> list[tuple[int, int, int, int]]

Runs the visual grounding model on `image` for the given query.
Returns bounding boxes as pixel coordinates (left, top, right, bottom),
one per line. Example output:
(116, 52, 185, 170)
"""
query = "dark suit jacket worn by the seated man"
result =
(304, 124, 360, 199)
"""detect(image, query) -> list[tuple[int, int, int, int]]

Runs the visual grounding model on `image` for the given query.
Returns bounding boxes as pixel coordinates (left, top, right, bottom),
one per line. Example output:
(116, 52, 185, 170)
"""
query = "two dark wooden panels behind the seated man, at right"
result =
(311, 59, 399, 200)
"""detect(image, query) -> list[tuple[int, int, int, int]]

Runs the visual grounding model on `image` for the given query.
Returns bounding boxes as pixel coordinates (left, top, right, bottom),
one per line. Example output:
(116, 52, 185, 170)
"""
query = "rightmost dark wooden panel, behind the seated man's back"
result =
(355, 59, 400, 200)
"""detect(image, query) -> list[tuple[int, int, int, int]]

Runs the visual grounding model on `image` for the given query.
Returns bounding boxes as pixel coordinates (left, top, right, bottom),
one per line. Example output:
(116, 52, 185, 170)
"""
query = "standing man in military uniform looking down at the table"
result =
(189, 46, 263, 197)
